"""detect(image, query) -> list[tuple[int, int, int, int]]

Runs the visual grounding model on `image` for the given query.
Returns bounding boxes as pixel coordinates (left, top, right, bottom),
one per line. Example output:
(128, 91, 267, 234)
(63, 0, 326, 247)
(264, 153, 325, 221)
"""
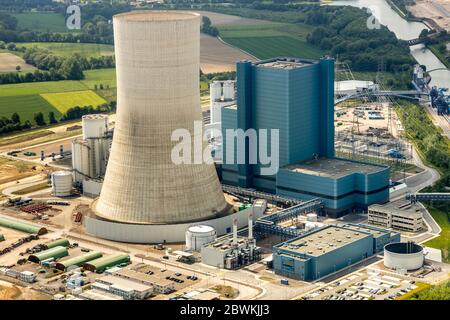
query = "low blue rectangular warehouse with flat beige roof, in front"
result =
(273, 224, 400, 280)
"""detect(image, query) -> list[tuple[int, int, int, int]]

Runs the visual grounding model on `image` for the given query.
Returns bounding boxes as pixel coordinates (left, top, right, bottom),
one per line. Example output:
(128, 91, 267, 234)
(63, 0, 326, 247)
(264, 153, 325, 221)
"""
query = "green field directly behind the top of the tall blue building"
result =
(218, 22, 323, 59)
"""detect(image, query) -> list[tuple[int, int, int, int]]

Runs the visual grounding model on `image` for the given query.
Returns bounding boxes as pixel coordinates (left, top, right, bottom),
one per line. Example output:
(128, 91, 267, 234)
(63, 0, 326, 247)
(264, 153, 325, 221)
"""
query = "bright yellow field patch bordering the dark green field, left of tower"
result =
(41, 90, 106, 114)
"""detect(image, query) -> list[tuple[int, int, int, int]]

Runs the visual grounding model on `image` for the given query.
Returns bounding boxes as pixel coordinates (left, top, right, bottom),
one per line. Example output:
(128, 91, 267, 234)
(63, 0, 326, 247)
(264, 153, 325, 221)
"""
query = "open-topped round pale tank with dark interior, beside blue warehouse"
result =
(384, 242, 424, 270)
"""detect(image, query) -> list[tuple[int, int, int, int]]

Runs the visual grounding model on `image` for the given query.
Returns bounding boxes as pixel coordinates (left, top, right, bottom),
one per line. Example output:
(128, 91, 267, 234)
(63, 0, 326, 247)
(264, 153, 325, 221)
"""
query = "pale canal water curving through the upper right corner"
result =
(330, 0, 450, 88)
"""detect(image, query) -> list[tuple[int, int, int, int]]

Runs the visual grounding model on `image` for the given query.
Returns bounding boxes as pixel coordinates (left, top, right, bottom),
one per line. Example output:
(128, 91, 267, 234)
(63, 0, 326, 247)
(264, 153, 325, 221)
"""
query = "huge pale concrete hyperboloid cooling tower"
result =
(95, 11, 229, 224)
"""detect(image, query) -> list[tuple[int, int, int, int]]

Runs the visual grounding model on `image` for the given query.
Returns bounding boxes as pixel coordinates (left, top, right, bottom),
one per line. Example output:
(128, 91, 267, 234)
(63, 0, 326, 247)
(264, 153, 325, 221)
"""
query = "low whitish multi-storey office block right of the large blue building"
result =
(367, 201, 423, 232)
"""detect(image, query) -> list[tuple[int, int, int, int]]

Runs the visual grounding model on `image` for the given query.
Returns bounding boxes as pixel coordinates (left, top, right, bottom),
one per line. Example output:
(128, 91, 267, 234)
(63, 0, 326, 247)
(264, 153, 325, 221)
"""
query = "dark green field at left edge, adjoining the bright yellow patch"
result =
(0, 94, 61, 123)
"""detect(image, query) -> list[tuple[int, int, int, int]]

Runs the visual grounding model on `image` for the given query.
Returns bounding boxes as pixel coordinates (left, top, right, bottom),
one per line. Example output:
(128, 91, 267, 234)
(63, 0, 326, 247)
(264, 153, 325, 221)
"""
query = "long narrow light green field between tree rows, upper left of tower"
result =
(18, 42, 114, 57)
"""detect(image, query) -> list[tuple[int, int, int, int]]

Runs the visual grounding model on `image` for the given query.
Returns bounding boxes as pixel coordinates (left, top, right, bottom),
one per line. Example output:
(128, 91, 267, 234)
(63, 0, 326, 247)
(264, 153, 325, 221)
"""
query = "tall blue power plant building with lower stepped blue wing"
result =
(221, 58, 390, 217)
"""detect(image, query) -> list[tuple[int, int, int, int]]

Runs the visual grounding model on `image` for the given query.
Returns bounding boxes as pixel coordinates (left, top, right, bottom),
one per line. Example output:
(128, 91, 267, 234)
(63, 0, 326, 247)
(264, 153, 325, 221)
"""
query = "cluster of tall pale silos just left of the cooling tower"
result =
(72, 114, 112, 197)
